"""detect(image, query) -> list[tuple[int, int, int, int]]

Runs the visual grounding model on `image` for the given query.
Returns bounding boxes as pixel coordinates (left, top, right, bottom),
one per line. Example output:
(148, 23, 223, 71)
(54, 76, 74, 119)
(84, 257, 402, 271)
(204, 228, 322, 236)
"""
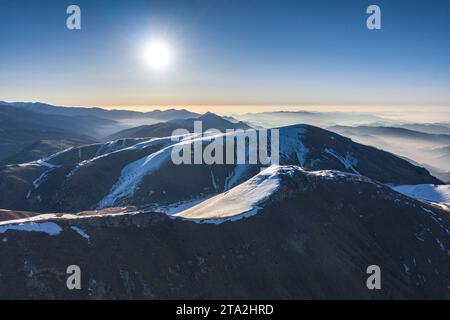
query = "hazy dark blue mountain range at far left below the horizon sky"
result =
(0, 102, 198, 165)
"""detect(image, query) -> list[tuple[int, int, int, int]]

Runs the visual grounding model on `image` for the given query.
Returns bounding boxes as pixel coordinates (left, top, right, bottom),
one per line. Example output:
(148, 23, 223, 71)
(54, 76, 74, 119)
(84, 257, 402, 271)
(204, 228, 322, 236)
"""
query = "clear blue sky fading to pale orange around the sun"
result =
(0, 0, 450, 108)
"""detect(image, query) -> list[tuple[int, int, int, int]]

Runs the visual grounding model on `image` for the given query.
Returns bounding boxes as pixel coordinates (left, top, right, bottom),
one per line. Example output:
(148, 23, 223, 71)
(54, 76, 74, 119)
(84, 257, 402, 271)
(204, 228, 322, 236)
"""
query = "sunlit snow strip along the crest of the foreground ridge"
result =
(0, 165, 436, 234)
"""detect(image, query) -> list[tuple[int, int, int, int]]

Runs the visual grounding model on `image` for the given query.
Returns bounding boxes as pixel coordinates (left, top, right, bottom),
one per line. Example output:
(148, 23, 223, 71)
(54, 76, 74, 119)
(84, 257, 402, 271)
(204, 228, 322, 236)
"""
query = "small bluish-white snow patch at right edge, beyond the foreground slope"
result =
(392, 184, 450, 204)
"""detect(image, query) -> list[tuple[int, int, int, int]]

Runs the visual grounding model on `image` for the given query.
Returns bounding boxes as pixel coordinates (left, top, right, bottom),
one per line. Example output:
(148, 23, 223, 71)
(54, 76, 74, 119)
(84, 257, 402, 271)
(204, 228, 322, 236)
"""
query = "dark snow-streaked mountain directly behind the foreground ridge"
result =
(0, 125, 441, 212)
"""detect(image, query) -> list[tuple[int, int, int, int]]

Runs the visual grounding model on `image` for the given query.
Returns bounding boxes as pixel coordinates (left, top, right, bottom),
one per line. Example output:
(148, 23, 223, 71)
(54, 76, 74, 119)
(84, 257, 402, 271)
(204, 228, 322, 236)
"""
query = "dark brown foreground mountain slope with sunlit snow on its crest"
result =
(0, 166, 450, 299)
